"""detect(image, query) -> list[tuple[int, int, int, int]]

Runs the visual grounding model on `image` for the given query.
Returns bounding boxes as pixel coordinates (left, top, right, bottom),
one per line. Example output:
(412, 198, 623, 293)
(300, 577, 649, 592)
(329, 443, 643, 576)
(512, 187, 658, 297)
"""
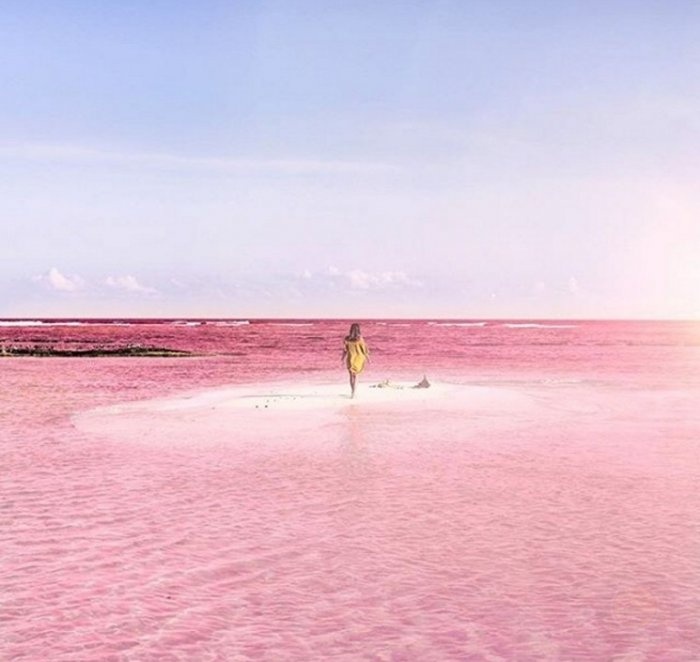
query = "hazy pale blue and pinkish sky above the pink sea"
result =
(0, 0, 700, 318)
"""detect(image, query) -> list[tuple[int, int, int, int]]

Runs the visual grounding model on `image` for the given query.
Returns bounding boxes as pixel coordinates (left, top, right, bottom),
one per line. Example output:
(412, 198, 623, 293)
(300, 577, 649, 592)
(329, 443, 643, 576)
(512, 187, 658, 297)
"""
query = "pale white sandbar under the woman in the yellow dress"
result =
(73, 382, 532, 443)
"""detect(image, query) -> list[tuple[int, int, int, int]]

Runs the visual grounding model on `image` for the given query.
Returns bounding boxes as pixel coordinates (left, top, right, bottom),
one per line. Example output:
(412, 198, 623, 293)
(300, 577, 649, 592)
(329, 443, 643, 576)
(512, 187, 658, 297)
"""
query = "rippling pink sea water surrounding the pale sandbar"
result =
(0, 321, 700, 661)
